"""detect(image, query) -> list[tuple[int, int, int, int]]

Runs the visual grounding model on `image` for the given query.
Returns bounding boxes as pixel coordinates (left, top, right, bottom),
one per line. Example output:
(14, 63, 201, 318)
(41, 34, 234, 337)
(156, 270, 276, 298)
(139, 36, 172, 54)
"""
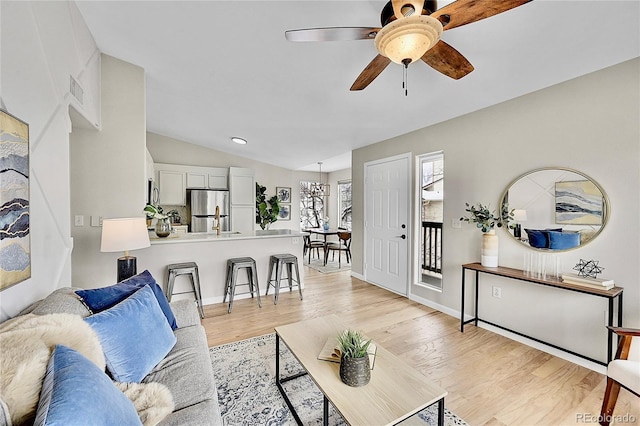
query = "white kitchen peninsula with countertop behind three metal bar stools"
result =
(135, 229, 304, 309)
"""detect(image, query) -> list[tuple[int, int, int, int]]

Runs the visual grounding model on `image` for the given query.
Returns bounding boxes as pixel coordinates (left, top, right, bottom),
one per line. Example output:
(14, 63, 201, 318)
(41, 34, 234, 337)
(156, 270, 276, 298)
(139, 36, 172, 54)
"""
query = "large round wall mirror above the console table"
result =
(500, 167, 609, 251)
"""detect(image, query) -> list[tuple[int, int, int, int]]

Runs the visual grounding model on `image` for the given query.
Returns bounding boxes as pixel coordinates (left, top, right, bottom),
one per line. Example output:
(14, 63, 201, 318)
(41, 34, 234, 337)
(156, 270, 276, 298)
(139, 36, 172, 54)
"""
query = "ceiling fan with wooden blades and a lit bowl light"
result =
(285, 0, 531, 90)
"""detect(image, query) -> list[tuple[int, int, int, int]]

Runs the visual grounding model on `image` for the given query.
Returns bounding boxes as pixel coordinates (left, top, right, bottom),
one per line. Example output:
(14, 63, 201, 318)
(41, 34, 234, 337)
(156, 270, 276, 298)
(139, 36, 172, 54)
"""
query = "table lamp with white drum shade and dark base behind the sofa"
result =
(100, 217, 151, 282)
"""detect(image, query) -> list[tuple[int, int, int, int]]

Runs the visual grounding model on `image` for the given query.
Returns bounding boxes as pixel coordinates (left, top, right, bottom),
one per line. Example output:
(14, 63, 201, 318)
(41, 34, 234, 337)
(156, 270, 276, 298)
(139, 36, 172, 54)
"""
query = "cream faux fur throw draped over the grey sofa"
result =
(0, 314, 174, 426)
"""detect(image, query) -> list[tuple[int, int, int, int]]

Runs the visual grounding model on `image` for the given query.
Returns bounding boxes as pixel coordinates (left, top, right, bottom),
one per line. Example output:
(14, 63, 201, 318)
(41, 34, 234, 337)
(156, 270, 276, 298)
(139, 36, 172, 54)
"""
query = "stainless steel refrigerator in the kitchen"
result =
(187, 189, 231, 232)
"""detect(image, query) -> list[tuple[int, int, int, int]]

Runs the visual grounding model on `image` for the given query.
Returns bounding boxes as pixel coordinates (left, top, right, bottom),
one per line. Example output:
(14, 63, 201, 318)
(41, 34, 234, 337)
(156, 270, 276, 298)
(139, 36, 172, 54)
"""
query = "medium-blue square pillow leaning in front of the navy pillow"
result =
(85, 286, 176, 383)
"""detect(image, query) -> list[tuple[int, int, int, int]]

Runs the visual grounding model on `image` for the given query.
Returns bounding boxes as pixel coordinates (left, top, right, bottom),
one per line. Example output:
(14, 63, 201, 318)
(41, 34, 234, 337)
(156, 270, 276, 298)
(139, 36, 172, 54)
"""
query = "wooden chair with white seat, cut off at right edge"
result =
(599, 326, 640, 426)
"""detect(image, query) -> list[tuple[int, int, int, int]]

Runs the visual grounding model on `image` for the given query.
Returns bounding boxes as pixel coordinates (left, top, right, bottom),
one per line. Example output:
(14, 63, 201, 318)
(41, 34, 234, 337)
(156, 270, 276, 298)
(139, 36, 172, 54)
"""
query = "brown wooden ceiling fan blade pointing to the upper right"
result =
(431, 0, 531, 30)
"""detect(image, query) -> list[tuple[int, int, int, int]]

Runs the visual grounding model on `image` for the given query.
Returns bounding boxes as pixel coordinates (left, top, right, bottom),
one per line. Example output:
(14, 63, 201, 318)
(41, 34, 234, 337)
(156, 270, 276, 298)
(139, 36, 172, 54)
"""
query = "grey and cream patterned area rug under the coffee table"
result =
(209, 334, 467, 426)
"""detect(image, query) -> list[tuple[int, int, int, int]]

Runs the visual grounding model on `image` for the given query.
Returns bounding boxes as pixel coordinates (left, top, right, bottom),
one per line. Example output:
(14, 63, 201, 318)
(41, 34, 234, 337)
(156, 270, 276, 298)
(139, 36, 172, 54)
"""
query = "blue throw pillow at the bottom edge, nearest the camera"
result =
(34, 345, 142, 426)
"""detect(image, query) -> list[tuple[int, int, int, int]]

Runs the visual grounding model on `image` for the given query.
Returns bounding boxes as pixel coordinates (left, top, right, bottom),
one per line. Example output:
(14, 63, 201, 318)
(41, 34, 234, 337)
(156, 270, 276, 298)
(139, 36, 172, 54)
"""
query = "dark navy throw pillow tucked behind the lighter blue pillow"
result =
(76, 270, 178, 330)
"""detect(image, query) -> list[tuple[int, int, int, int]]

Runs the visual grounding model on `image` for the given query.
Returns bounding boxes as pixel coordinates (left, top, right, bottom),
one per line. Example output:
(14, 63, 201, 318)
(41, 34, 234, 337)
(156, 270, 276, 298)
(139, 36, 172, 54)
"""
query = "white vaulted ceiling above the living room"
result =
(77, 0, 640, 171)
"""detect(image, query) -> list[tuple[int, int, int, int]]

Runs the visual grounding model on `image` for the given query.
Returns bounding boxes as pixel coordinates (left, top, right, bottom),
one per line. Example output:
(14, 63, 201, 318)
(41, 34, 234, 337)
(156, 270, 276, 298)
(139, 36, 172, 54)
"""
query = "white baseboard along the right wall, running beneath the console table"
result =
(410, 295, 607, 375)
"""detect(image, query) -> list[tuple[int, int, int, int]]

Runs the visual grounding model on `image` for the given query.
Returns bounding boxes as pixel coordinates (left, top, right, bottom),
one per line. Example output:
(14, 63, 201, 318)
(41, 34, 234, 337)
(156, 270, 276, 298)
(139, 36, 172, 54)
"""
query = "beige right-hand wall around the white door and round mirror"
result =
(352, 59, 640, 359)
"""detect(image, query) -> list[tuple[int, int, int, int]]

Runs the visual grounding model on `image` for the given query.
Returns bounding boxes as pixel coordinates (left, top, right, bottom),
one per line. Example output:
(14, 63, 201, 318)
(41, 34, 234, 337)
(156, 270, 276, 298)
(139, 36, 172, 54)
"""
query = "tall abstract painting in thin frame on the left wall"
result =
(0, 110, 31, 290)
